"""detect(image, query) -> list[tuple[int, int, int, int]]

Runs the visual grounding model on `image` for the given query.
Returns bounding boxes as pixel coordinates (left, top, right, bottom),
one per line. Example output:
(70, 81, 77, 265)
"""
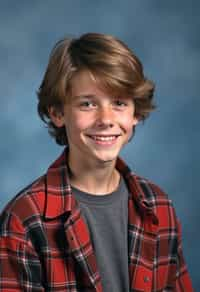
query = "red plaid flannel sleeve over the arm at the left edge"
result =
(0, 211, 44, 292)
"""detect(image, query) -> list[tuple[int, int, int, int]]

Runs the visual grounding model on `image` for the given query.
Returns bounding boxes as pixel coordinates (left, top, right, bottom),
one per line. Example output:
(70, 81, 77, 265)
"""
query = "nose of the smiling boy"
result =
(96, 106, 114, 127)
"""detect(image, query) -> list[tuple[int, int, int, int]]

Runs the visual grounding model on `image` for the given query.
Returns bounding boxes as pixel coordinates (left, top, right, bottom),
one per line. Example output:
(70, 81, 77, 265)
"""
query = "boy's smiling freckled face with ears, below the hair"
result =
(51, 72, 138, 163)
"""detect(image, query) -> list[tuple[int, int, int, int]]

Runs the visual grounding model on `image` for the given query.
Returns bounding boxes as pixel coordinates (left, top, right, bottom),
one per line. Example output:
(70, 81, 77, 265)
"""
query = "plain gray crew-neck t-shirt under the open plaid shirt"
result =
(72, 177, 129, 292)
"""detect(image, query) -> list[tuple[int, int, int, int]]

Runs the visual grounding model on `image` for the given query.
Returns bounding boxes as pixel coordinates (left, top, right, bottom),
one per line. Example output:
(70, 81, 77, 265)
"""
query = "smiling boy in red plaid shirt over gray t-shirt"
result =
(0, 33, 193, 292)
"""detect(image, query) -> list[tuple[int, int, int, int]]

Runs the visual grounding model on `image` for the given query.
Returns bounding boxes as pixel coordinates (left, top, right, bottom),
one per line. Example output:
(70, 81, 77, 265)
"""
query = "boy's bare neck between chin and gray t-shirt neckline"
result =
(68, 155, 120, 195)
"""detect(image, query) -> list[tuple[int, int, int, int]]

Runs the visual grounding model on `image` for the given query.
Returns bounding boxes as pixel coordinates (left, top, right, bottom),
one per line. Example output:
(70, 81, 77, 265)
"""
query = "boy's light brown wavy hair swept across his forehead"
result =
(37, 33, 155, 145)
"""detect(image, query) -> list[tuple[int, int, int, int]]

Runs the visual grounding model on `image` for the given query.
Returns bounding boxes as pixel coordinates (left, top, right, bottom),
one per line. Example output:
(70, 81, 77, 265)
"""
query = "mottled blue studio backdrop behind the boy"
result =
(0, 0, 200, 291)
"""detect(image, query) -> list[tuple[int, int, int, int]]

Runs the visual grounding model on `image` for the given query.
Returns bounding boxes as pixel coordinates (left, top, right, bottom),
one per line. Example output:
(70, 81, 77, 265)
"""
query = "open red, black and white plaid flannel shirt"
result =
(0, 148, 193, 292)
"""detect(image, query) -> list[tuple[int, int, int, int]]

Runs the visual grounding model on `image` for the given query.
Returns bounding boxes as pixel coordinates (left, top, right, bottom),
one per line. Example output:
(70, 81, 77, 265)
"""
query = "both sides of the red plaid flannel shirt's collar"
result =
(44, 147, 157, 220)
